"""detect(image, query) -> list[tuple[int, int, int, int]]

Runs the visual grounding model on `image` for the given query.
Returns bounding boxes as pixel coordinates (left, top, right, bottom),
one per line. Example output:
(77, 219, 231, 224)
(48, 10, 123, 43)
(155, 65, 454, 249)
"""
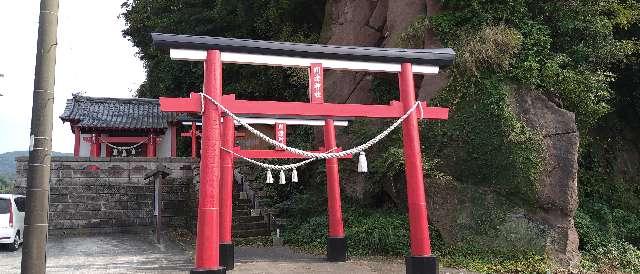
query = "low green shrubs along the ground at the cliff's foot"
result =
(283, 200, 548, 273)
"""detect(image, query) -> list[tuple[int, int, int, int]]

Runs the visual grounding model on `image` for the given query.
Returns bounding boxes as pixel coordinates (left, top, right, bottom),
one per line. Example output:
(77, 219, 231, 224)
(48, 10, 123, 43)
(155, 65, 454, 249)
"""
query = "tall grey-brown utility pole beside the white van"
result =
(21, 0, 58, 274)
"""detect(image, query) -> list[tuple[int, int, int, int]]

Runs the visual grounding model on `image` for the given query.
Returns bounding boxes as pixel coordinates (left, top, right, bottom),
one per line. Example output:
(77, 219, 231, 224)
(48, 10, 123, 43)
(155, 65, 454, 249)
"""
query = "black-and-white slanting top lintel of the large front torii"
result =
(151, 33, 455, 74)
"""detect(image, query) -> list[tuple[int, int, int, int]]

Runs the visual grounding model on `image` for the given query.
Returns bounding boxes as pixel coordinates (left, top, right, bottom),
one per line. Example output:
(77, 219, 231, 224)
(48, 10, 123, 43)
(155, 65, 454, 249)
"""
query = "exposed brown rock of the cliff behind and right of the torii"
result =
(321, 0, 579, 267)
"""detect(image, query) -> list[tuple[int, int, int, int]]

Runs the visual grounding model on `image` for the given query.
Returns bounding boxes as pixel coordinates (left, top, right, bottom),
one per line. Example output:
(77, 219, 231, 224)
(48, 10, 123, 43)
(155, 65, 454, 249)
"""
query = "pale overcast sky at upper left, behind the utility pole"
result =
(0, 0, 144, 153)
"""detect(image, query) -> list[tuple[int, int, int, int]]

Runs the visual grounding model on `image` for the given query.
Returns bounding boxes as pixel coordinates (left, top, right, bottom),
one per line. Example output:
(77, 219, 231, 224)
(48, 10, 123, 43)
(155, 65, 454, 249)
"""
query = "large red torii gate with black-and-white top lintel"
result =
(152, 34, 454, 273)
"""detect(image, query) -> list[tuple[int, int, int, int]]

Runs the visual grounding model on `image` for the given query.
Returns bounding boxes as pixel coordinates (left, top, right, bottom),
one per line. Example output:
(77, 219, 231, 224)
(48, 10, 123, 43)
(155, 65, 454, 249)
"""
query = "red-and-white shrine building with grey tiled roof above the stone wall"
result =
(60, 95, 178, 157)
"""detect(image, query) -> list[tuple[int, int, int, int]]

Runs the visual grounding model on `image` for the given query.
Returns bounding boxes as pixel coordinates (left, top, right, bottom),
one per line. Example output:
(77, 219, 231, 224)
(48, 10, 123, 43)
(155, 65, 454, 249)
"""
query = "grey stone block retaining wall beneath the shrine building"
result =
(16, 157, 198, 230)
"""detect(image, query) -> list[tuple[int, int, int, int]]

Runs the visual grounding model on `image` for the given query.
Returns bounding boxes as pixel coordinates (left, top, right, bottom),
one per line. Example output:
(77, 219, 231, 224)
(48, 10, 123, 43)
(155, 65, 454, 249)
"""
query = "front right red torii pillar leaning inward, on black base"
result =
(399, 63, 438, 274)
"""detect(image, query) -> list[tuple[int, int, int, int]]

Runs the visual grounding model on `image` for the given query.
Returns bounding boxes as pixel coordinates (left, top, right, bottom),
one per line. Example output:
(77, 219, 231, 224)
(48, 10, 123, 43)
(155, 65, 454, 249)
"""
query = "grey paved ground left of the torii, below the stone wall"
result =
(0, 231, 192, 273)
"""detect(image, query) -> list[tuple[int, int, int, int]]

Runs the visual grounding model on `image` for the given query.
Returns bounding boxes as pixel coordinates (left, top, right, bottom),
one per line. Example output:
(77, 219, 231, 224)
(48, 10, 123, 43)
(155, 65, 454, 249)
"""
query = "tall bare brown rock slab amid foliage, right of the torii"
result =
(514, 92, 580, 268)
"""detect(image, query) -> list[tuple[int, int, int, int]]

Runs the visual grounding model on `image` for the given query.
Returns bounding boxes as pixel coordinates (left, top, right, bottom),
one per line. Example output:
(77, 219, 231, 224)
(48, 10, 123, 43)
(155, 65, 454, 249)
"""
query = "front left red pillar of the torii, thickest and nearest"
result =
(191, 50, 226, 273)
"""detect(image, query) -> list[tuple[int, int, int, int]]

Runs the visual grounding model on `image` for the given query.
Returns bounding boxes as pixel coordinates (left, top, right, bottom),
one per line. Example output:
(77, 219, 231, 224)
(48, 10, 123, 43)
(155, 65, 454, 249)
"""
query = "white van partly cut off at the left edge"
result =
(0, 194, 27, 251)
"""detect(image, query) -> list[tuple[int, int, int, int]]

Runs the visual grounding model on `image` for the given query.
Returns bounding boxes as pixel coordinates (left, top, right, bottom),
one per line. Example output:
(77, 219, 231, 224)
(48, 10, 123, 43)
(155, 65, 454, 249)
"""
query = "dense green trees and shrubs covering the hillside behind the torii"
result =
(123, 0, 640, 272)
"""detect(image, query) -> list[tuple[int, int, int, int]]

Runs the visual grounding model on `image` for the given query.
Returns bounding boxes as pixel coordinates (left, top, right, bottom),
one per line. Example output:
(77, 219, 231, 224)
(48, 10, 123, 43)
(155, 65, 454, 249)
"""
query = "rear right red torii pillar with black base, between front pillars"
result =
(324, 119, 347, 262)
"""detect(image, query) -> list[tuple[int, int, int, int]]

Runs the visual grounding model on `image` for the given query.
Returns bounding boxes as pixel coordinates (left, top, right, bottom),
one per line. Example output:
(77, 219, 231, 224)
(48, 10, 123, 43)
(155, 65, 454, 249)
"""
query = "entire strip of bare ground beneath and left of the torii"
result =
(0, 233, 467, 274)
